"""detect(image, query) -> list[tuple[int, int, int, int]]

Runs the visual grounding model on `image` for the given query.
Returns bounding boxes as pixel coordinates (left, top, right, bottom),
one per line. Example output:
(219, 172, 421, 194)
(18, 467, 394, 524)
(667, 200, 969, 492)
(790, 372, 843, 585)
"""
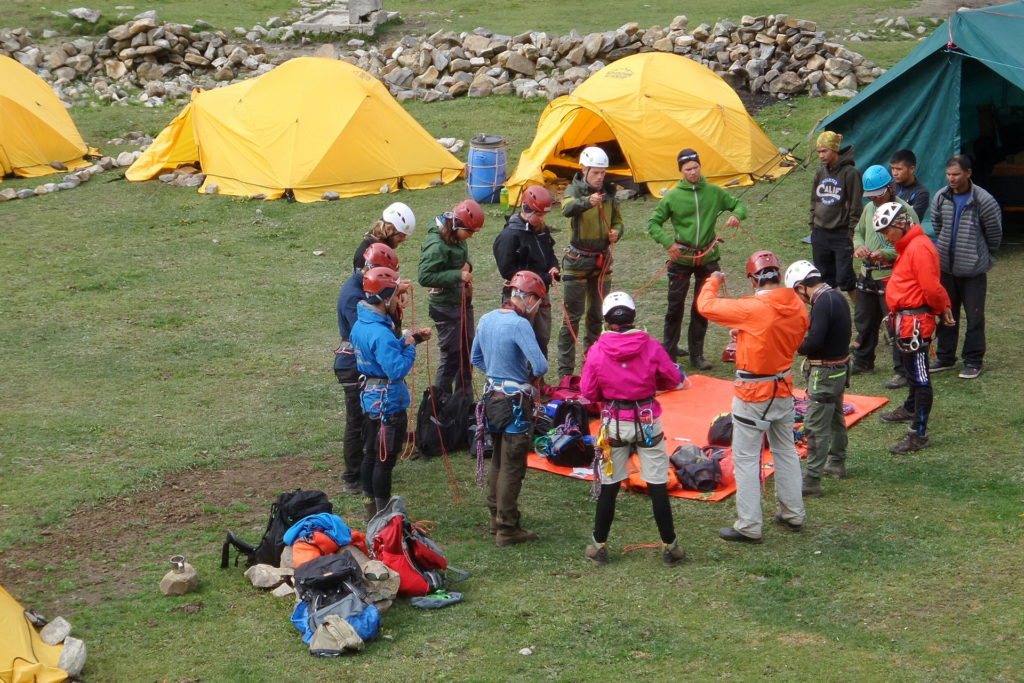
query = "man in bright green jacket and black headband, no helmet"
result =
(647, 147, 746, 370)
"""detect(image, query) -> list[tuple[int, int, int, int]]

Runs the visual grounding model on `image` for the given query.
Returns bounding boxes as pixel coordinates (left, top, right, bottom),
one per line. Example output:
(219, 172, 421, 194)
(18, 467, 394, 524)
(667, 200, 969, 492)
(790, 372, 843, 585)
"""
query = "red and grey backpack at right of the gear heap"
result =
(367, 496, 447, 598)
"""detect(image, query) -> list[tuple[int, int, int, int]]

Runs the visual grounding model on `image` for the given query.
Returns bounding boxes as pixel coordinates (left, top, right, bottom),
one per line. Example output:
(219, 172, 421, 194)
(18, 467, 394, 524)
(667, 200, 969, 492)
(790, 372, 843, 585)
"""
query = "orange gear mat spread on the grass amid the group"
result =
(526, 375, 889, 503)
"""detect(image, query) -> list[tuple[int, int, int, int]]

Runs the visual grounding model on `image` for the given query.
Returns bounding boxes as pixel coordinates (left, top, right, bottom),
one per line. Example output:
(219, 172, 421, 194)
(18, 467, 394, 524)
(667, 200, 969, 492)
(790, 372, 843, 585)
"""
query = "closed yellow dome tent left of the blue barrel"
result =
(125, 57, 463, 202)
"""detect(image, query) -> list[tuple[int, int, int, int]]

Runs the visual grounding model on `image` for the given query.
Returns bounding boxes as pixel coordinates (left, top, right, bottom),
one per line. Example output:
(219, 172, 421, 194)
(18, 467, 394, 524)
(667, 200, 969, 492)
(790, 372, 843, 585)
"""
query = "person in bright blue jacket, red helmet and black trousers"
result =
(349, 267, 430, 521)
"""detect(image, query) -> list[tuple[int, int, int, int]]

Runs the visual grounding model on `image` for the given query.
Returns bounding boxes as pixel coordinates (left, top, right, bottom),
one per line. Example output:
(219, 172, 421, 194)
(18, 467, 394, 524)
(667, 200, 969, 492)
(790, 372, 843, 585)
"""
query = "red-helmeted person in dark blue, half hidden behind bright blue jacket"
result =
(334, 243, 402, 495)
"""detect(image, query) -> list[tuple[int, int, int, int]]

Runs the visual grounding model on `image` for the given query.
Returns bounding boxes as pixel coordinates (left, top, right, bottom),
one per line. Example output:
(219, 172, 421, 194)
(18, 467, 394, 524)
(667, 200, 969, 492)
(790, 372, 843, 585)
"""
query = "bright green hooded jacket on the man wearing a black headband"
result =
(647, 175, 746, 265)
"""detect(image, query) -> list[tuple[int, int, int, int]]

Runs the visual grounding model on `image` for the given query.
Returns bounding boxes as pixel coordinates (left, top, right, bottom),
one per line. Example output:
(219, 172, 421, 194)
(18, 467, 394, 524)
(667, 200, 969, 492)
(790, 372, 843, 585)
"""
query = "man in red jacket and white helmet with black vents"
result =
(873, 202, 955, 456)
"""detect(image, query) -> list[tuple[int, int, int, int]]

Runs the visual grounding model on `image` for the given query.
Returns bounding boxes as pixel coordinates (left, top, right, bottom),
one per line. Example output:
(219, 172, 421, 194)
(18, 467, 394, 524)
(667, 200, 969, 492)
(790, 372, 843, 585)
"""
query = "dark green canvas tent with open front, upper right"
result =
(820, 2, 1024, 206)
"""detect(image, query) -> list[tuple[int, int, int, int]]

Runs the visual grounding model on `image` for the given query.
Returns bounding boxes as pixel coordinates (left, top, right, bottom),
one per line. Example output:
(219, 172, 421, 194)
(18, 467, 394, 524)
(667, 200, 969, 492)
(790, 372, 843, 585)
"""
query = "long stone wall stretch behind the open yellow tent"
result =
(358, 14, 883, 101)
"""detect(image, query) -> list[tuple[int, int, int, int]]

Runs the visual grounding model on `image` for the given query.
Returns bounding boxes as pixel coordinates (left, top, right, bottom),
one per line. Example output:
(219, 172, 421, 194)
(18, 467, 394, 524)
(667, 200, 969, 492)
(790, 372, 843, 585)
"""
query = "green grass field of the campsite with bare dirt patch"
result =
(0, 0, 1024, 681)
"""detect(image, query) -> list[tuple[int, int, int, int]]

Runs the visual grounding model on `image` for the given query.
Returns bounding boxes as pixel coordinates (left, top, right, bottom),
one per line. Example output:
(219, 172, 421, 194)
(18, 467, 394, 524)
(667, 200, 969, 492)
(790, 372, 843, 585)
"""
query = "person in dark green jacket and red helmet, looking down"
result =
(419, 200, 483, 397)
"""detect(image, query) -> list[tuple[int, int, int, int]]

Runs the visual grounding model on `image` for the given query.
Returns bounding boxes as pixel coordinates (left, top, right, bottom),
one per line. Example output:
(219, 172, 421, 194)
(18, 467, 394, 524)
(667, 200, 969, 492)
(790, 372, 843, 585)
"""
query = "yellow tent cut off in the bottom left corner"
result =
(0, 586, 68, 683)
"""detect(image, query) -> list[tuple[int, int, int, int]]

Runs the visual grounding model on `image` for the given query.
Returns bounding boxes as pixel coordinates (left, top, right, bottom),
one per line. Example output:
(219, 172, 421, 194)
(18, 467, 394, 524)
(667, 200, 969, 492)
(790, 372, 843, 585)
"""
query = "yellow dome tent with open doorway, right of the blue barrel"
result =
(506, 52, 792, 202)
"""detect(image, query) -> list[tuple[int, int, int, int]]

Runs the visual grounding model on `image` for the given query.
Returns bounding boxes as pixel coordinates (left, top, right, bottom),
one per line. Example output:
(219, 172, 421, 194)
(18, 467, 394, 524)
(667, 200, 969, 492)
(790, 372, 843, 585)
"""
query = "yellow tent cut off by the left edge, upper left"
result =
(0, 55, 91, 178)
